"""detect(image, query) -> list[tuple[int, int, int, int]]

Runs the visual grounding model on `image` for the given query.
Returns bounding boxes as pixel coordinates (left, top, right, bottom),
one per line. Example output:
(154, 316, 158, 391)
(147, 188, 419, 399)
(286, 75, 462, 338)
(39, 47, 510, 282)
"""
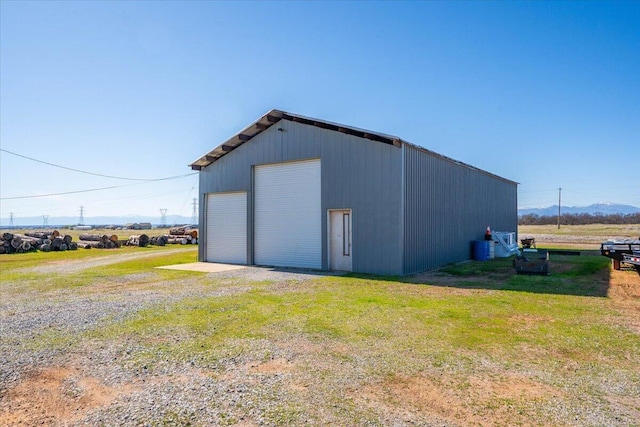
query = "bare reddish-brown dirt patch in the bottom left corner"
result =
(0, 367, 127, 426)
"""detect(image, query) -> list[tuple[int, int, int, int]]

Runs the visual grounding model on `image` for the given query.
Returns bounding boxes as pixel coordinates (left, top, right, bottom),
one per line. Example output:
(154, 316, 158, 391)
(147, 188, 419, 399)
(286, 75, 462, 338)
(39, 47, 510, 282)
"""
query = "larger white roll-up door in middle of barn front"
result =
(254, 160, 322, 268)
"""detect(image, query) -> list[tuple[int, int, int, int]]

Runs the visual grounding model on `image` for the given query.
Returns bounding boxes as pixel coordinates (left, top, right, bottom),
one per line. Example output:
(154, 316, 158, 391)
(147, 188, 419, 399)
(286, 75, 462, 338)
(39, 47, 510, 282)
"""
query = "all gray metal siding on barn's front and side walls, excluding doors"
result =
(199, 120, 517, 275)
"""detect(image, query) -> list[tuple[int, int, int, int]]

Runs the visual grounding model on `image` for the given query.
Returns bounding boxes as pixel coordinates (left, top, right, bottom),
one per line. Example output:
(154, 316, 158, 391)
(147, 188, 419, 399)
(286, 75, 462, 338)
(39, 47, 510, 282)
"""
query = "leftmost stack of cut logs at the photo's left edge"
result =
(0, 230, 78, 254)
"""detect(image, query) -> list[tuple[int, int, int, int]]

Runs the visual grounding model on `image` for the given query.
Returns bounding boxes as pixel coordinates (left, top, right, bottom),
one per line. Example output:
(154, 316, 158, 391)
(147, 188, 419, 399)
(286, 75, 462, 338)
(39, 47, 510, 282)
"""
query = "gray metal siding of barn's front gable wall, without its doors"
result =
(199, 120, 402, 275)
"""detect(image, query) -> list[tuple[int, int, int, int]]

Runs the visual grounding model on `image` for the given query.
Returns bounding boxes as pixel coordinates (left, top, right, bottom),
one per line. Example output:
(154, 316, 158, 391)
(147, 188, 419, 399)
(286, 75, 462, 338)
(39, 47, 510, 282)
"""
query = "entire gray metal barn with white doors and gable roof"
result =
(190, 110, 517, 275)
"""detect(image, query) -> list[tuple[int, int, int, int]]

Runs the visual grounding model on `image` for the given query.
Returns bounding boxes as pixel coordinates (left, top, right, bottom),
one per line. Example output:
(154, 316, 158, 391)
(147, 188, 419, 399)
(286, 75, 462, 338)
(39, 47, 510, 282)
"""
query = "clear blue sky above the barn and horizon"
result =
(0, 1, 640, 224)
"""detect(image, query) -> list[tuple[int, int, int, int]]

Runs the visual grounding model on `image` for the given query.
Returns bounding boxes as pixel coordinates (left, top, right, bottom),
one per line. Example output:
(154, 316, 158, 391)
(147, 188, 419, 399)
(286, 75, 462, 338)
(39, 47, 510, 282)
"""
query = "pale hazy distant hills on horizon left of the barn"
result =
(0, 215, 191, 227)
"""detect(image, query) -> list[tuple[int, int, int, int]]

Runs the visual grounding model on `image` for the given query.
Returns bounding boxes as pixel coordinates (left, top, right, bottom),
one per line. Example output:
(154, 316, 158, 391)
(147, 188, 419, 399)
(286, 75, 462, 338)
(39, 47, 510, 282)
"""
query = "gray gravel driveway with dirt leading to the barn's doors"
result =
(0, 254, 348, 426)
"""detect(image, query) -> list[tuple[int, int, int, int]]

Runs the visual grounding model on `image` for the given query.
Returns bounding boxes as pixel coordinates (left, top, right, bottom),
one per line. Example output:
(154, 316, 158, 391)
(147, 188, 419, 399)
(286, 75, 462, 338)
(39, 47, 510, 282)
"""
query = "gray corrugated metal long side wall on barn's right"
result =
(403, 146, 518, 274)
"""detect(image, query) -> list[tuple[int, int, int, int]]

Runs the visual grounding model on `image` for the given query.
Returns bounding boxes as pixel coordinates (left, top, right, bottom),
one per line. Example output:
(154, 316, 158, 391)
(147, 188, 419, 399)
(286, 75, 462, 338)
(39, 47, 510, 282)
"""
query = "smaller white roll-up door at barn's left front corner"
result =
(206, 192, 247, 264)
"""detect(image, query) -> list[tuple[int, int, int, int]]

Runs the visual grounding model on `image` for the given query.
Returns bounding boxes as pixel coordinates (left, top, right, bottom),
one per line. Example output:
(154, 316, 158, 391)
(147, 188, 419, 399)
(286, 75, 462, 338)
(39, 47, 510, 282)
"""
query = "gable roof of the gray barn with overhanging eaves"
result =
(189, 109, 517, 184)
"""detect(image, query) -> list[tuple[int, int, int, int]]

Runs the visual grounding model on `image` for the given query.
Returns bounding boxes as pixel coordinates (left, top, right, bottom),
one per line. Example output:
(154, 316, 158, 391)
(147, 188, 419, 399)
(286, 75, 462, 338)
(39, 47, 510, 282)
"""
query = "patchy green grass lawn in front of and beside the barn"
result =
(1, 246, 640, 426)
